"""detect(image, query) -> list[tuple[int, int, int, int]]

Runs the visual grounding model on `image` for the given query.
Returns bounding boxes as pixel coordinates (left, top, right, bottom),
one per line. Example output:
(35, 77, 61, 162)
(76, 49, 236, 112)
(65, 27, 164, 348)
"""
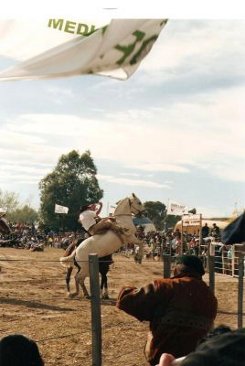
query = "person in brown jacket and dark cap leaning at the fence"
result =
(116, 255, 217, 365)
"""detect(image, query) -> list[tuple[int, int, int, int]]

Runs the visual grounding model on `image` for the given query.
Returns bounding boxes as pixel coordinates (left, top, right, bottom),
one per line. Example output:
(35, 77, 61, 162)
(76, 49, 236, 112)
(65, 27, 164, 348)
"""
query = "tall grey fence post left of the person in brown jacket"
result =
(89, 254, 102, 366)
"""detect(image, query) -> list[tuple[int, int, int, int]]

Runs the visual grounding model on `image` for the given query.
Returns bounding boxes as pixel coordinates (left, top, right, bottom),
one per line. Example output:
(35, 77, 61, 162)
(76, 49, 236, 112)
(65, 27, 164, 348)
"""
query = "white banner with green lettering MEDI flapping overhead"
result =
(0, 19, 167, 80)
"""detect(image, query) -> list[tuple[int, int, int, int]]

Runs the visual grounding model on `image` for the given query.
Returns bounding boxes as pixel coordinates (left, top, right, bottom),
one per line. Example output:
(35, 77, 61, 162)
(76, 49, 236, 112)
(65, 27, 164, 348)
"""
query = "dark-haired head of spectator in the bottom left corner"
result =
(0, 334, 44, 366)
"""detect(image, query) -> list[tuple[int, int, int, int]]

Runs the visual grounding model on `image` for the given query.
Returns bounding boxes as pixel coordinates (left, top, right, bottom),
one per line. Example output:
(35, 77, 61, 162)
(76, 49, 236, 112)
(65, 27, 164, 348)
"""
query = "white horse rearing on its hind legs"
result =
(60, 193, 144, 297)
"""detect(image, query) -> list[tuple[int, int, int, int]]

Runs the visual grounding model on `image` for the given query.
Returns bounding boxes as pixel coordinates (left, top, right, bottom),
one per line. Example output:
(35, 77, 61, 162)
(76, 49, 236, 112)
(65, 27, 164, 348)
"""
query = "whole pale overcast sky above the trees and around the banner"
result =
(0, 19, 245, 217)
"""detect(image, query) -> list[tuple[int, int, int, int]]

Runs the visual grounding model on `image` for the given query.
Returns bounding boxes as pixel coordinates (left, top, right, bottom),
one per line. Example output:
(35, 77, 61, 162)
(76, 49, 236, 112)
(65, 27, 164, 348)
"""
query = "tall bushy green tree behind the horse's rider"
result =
(39, 150, 103, 231)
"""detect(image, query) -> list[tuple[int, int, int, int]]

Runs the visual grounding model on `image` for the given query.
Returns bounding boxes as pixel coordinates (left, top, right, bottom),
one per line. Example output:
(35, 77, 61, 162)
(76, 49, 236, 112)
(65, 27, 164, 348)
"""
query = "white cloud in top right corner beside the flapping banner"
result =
(141, 19, 245, 78)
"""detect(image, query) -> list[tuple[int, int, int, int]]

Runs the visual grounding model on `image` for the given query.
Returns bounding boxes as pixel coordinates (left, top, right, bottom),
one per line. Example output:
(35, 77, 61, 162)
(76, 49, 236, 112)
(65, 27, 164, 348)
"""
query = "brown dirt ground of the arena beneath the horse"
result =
(0, 248, 243, 366)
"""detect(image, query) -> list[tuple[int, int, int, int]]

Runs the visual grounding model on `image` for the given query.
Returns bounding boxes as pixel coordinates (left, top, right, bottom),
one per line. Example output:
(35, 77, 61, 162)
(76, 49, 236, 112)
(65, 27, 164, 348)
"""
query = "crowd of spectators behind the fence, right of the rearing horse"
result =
(127, 224, 237, 275)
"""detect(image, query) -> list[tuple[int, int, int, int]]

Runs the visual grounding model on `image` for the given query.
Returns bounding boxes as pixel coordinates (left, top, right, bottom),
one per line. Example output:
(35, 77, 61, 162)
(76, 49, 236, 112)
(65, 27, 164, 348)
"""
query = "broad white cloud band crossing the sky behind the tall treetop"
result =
(0, 79, 245, 181)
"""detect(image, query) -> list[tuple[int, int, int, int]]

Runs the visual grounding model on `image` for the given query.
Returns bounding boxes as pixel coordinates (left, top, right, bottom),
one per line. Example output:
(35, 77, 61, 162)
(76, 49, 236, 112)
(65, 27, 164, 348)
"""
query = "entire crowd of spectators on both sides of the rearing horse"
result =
(0, 219, 237, 275)
